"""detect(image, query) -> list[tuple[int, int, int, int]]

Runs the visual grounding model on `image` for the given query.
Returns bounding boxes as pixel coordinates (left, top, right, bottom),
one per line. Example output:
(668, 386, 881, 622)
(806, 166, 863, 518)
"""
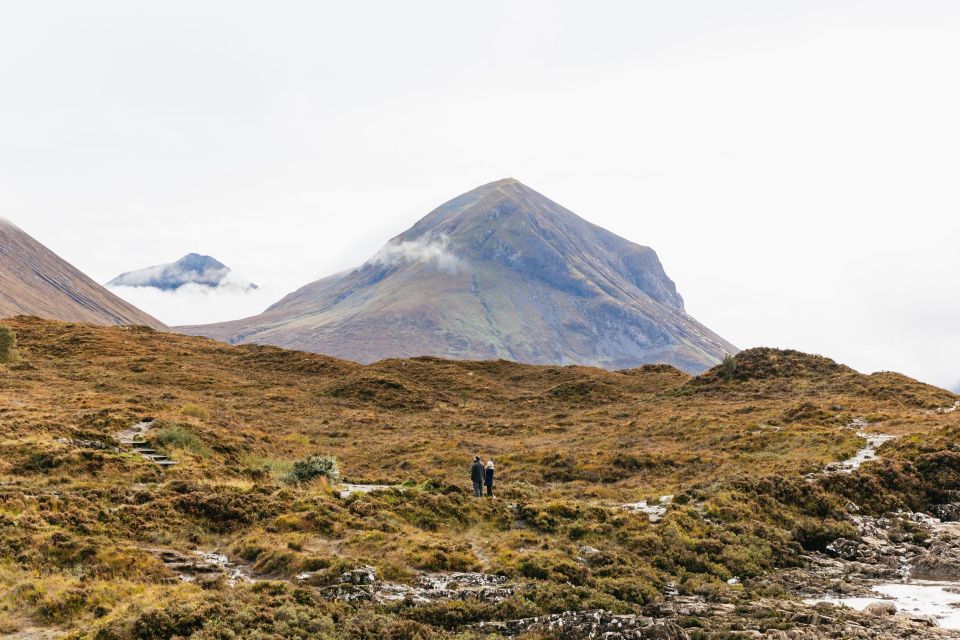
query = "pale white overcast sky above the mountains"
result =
(0, 0, 960, 386)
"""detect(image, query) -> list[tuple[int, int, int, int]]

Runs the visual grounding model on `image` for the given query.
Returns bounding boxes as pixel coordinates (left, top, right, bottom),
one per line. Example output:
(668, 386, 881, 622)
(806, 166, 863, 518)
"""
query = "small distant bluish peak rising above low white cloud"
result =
(107, 253, 257, 291)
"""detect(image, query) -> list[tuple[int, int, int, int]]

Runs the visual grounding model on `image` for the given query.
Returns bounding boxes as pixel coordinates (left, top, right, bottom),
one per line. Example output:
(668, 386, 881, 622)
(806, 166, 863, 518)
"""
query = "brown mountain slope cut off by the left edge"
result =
(0, 218, 166, 329)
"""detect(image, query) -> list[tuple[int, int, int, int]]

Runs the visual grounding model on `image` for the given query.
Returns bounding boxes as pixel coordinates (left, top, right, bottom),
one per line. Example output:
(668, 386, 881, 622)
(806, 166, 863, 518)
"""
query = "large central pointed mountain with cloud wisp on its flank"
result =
(182, 179, 737, 372)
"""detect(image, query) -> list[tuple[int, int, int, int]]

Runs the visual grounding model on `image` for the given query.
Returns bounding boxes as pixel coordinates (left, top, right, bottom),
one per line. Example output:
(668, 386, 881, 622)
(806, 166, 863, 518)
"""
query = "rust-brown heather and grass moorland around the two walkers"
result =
(0, 318, 960, 638)
